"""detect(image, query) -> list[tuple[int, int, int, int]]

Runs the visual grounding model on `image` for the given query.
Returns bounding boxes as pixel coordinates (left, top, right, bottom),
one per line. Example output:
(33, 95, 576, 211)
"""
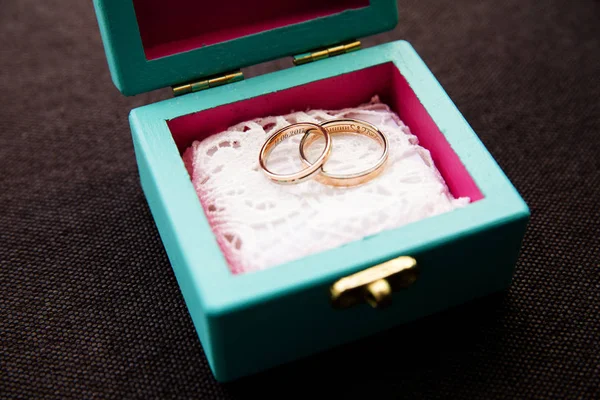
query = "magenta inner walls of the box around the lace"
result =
(167, 62, 483, 202)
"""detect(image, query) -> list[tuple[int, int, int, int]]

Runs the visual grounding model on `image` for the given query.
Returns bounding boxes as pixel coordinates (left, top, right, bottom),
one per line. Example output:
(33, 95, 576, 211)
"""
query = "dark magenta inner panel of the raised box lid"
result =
(133, 0, 369, 60)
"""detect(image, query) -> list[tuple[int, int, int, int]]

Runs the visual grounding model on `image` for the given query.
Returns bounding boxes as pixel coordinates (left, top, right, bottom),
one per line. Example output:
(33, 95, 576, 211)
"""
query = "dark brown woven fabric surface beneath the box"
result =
(0, 0, 600, 399)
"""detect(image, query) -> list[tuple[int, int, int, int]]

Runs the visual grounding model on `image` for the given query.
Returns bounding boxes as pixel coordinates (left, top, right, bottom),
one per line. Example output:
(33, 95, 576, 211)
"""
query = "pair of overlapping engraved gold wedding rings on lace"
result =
(258, 119, 388, 187)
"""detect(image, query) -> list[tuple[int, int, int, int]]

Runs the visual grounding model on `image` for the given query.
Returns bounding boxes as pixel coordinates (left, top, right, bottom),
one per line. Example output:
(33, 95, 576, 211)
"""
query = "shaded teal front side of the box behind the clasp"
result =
(211, 213, 528, 381)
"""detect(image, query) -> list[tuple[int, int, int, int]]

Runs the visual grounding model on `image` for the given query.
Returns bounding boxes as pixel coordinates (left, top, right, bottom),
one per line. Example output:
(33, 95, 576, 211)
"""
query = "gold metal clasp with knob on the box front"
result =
(330, 256, 419, 309)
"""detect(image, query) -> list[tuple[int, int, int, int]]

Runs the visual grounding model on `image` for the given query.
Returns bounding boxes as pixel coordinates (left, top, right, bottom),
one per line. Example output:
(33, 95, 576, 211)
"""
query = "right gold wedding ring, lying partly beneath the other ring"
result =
(300, 119, 388, 187)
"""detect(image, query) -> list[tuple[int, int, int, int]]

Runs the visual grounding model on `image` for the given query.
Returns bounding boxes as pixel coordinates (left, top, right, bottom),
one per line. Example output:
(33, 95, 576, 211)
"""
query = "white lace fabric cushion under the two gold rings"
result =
(184, 97, 469, 274)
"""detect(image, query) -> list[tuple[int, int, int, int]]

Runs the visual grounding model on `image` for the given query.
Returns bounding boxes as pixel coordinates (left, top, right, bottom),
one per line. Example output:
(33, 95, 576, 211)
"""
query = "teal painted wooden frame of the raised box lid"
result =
(94, 0, 398, 95)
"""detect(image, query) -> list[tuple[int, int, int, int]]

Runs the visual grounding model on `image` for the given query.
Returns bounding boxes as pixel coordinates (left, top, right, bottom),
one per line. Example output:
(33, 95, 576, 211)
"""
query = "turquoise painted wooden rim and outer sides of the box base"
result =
(130, 41, 529, 381)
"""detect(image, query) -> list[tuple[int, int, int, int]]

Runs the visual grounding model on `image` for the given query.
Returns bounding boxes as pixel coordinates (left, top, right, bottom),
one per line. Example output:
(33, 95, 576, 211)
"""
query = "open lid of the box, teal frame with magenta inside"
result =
(94, 0, 398, 96)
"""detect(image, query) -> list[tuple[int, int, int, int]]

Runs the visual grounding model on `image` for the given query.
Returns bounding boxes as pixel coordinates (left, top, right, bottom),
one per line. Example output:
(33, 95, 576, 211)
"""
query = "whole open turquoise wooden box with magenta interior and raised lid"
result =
(94, 0, 529, 381)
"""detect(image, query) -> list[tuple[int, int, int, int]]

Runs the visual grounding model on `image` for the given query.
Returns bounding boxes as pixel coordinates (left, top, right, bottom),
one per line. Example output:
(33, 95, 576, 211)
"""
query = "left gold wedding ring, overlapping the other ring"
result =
(258, 122, 331, 184)
